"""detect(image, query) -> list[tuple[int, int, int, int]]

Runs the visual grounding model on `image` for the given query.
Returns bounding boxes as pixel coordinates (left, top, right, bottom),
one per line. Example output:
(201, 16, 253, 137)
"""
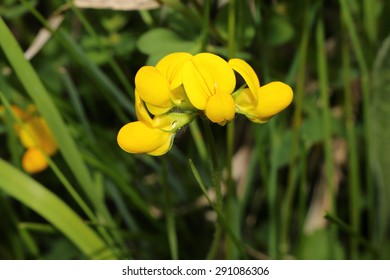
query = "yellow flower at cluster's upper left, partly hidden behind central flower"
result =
(135, 52, 192, 115)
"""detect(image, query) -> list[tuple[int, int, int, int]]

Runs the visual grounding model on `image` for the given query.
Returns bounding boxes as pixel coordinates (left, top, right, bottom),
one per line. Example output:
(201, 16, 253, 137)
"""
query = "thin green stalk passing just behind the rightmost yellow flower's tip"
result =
(280, 0, 315, 255)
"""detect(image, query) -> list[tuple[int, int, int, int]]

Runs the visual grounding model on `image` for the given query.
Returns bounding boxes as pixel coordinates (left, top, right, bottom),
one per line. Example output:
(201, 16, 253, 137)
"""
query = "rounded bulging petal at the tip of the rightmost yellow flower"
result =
(256, 82, 293, 122)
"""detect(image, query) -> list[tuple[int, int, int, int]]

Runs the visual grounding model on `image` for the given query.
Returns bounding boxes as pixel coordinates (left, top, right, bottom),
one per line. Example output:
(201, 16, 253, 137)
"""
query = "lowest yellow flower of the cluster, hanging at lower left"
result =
(117, 91, 194, 156)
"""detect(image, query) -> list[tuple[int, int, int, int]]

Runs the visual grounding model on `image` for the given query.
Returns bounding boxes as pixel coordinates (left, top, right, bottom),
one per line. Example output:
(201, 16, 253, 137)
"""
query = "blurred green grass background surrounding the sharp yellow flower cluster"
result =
(0, 0, 390, 259)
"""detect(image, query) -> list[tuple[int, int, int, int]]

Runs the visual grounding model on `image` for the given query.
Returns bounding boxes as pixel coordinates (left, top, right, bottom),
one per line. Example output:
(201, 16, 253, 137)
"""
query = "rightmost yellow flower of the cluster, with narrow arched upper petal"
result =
(229, 58, 293, 123)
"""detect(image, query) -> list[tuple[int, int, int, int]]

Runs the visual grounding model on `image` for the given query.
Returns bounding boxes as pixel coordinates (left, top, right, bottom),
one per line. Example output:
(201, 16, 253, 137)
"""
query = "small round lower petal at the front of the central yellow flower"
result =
(205, 93, 235, 125)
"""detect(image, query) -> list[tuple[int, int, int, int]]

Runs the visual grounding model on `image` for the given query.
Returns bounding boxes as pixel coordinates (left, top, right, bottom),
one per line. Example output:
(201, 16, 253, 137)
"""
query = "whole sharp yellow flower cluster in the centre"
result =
(117, 52, 293, 156)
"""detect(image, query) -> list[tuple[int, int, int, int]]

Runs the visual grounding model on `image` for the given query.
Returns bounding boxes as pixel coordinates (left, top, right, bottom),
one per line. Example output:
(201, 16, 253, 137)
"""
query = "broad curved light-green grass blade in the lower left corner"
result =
(0, 159, 115, 259)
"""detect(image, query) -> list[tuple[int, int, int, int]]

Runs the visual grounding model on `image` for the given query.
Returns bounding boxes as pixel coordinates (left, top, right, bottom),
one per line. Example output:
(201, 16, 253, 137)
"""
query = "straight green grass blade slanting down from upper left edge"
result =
(0, 18, 96, 207)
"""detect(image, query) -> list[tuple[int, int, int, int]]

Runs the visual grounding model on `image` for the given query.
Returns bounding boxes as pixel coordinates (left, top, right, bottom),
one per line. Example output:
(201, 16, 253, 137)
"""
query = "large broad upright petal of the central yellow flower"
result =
(183, 53, 236, 110)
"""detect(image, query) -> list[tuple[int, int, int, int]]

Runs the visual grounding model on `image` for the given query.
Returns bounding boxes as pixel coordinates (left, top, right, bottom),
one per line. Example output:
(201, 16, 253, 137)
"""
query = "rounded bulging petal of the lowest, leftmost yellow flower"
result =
(117, 121, 173, 154)
